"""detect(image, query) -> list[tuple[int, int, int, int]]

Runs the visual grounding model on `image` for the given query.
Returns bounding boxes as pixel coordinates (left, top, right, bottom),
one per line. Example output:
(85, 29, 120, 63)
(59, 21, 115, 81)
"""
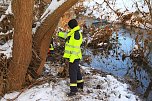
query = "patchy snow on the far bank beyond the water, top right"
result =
(83, 0, 152, 29)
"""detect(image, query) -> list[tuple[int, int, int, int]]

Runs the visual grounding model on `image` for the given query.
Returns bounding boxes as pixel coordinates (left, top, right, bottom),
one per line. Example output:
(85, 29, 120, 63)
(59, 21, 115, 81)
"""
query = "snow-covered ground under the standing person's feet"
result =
(1, 64, 140, 101)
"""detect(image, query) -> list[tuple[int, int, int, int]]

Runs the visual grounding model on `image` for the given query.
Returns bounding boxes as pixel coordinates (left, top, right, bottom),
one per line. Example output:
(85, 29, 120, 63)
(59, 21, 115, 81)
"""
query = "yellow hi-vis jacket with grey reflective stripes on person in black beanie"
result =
(58, 26, 82, 63)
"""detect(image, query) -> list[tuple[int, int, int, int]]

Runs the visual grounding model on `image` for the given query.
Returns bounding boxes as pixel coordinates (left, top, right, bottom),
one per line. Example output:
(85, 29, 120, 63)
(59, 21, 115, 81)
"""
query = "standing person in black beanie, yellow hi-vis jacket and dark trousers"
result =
(58, 19, 84, 96)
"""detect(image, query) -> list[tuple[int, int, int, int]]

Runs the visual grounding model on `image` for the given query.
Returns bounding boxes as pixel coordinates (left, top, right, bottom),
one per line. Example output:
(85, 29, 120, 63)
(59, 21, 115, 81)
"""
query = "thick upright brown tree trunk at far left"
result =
(8, 0, 34, 90)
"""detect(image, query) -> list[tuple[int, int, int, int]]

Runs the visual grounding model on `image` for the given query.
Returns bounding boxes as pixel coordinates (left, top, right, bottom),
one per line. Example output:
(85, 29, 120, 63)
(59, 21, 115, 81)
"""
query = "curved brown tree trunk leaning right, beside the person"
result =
(29, 0, 78, 76)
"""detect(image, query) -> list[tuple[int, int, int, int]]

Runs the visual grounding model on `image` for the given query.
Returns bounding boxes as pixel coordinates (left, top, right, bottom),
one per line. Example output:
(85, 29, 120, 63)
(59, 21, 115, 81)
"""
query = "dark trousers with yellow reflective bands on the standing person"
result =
(69, 59, 83, 92)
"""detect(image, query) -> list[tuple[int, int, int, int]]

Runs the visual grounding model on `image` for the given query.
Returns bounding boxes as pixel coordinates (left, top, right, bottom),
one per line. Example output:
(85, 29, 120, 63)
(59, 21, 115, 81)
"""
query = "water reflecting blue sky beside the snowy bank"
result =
(82, 24, 152, 101)
